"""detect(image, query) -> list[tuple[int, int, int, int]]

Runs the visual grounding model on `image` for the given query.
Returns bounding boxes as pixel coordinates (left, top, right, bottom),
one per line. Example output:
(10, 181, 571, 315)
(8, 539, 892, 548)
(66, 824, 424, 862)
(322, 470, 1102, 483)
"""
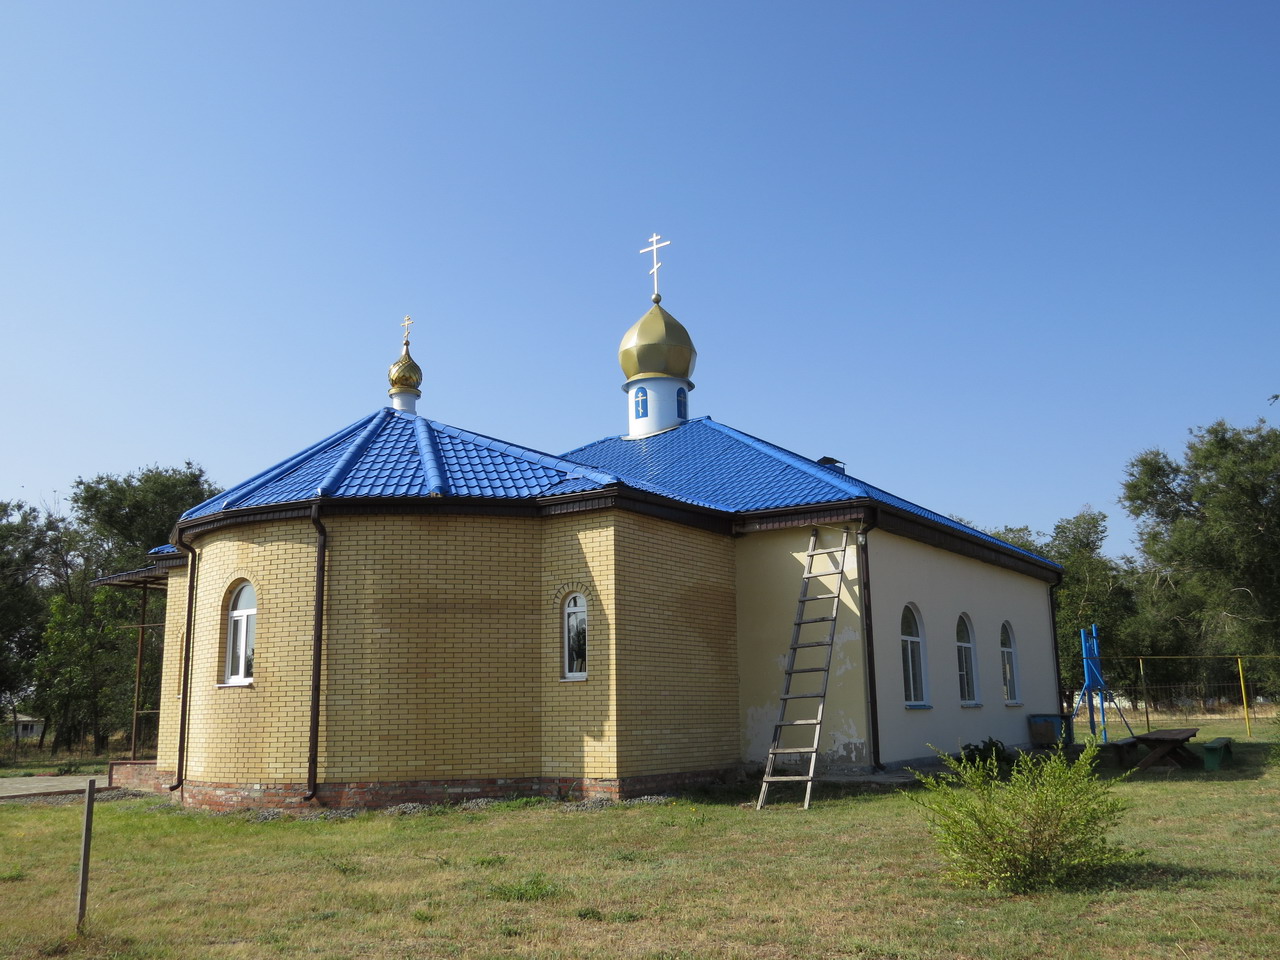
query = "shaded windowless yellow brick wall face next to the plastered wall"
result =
(616, 513, 740, 777)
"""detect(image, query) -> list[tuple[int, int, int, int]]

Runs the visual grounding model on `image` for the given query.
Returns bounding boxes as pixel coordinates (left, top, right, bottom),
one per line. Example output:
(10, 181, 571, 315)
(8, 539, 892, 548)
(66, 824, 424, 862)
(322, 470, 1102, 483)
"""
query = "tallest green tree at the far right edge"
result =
(1121, 420, 1280, 691)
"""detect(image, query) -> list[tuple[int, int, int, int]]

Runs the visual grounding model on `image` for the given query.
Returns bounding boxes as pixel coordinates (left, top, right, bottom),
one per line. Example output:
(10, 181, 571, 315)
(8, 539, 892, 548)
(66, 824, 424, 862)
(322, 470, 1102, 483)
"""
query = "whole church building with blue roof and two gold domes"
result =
(109, 256, 1061, 809)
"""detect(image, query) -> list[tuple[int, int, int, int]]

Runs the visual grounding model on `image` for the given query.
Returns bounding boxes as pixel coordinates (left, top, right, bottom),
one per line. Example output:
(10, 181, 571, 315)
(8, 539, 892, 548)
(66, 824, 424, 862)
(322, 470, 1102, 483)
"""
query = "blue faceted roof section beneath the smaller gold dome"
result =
(182, 407, 617, 520)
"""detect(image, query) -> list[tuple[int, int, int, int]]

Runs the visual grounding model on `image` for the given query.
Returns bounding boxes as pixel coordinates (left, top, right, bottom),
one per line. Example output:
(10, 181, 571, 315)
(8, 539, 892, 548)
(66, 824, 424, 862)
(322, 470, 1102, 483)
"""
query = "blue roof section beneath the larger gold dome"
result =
(564, 417, 1043, 568)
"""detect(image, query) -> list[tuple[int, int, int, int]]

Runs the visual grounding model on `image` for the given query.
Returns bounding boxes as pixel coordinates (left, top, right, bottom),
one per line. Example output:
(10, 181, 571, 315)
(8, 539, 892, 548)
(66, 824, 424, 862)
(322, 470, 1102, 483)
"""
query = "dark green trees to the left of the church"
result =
(0, 462, 216, 753)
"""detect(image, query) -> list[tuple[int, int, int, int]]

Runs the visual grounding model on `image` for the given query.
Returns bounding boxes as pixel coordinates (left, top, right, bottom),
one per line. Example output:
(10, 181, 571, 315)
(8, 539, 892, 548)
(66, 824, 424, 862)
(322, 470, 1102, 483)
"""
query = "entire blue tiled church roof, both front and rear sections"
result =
(175, 407, 1043, 570)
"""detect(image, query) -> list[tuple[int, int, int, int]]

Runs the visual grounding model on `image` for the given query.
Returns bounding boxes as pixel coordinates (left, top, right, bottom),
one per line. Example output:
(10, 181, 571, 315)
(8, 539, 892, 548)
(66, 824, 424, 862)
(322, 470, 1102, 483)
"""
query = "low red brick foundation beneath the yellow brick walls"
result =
(165, 764, 732, 810)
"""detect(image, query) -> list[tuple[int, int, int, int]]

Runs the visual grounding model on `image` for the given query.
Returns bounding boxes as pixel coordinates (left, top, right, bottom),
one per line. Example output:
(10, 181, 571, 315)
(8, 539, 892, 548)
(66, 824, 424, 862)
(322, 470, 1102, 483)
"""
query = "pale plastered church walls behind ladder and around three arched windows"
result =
(736, 525, 1059, 772)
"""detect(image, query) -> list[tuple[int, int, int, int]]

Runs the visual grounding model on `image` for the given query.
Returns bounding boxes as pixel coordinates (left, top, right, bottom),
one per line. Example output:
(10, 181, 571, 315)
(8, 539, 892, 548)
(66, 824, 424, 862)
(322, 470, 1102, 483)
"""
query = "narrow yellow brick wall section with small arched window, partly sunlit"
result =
(538, 511, 618, 780)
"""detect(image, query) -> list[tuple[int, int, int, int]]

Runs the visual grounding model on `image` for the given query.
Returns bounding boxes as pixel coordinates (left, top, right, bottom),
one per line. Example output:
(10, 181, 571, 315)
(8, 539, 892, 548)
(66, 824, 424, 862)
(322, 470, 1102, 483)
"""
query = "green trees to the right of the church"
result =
(989, 420, 1280, 696)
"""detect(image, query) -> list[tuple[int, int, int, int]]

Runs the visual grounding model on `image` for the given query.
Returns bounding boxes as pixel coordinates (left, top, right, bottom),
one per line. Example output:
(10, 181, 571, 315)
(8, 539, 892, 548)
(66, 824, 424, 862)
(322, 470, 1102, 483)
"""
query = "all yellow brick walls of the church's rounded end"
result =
(159, 511, 739, 783)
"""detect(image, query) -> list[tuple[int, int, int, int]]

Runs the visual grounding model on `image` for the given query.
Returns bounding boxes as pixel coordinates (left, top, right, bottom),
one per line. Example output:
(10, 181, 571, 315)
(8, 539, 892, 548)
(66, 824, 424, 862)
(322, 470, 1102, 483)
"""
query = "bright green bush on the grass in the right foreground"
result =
(914, 741, 1138, 893)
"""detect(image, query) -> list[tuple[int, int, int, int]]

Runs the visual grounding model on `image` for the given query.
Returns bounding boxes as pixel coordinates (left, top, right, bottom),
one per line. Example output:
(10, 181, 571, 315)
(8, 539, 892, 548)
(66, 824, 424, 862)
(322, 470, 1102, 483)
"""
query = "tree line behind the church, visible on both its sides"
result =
(0, 421, 1280, 751)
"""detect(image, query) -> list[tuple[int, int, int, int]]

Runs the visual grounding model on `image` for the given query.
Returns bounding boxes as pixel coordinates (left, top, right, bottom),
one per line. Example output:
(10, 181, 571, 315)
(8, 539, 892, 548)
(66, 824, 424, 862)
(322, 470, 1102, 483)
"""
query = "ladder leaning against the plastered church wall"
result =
(755, 527, 849, 810)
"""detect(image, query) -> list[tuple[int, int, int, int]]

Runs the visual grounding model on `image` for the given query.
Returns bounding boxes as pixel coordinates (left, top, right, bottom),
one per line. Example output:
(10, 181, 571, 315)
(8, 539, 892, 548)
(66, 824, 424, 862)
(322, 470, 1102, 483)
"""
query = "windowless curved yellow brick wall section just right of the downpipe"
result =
(320, 516, 540, 782)
